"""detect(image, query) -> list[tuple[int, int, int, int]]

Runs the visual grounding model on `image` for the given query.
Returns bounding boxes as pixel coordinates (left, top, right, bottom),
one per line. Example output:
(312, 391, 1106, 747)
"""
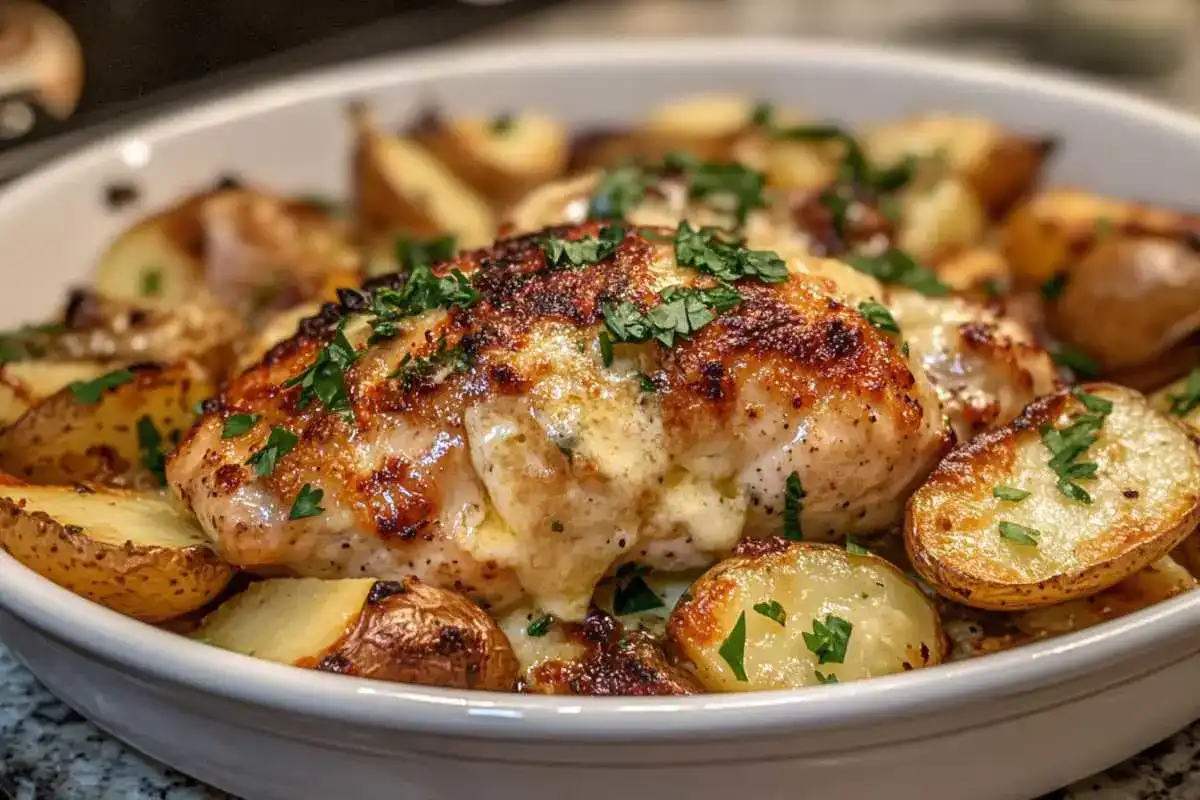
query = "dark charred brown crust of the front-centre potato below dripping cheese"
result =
(520, 608, 704, 697)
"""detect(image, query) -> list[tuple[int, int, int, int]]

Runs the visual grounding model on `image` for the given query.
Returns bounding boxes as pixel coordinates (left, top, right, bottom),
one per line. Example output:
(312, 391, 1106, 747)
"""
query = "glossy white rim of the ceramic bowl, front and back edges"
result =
(0, 38, 1200, 742)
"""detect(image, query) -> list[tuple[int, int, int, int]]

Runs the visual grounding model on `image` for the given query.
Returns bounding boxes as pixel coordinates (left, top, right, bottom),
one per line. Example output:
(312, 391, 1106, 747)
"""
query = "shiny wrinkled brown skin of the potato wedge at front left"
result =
(309, 578, 518, 692)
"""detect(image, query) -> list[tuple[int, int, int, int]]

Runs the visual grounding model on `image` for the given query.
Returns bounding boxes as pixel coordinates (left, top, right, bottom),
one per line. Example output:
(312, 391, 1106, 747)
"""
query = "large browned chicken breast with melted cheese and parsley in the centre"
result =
(167, 223, 952, 619)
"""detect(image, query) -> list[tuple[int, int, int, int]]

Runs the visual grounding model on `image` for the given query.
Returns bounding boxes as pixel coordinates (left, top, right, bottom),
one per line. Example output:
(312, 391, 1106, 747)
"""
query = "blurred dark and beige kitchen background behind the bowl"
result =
(0, 0, 1200, 180)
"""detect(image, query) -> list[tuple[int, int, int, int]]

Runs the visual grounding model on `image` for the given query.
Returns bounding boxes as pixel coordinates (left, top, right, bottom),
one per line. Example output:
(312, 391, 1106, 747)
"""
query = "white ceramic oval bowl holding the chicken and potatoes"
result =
(0, 41, 1200, 800)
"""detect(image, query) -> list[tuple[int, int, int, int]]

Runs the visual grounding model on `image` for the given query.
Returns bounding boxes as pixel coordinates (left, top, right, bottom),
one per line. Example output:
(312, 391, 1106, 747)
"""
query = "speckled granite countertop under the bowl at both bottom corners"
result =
(0, 645, 1200, 800)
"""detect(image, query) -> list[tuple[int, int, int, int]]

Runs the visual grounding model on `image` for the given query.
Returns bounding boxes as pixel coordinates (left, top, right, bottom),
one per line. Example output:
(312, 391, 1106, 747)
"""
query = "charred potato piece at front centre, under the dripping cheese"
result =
(500, 608, 702, 696)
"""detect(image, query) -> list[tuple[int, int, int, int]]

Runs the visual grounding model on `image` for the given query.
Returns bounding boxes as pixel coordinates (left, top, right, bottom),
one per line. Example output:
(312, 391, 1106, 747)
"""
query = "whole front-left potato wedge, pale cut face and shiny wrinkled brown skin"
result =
(192, 578, 517, 691)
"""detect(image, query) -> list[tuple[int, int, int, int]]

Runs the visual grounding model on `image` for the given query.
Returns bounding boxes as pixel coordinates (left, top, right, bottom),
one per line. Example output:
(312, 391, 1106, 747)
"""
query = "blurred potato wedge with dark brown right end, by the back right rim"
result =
(863, 114, 1054, 219)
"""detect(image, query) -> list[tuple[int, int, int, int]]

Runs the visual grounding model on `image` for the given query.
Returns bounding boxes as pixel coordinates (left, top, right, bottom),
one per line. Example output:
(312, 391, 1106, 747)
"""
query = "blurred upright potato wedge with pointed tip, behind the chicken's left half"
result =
(350, 106, 496, 247)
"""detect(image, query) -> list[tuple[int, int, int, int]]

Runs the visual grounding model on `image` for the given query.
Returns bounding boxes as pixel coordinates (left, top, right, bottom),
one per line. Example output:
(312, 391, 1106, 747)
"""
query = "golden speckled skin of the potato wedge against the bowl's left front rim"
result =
(0, 489, 233, 622)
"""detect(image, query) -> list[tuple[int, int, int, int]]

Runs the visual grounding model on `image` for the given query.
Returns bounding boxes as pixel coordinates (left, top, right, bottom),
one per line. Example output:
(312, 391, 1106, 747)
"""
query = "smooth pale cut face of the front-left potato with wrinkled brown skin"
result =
(192, 578, 377, 664)
